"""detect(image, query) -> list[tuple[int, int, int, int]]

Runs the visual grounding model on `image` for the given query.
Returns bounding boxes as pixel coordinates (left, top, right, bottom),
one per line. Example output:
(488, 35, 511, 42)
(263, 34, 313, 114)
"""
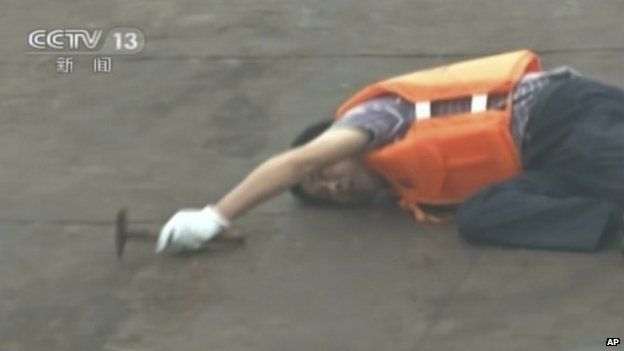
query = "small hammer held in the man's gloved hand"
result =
(115, 208, 245, 261)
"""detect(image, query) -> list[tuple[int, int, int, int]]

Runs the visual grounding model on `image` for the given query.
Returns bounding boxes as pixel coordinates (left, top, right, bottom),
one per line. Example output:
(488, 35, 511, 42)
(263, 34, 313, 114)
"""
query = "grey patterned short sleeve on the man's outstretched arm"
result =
(331, 95, 414, 149)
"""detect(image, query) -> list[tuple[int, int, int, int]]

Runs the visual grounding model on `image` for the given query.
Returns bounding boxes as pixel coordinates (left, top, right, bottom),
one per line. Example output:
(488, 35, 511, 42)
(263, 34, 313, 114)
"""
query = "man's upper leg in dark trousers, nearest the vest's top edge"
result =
(523, 78, 624, 208)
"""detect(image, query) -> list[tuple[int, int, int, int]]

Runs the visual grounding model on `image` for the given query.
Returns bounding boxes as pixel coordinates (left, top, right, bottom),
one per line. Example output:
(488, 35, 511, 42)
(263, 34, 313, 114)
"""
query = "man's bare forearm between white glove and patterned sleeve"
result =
(216, 128, 369, 219)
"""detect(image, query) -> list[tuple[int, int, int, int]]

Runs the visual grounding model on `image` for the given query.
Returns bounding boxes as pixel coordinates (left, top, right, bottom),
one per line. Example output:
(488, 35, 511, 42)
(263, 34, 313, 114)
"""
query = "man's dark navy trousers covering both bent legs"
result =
(457, 78, 624, 251)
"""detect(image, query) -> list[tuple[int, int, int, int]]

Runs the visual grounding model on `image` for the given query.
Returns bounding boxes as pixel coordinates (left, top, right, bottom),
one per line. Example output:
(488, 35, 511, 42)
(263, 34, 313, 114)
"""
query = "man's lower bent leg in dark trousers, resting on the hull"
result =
(457, 172, 621, 251)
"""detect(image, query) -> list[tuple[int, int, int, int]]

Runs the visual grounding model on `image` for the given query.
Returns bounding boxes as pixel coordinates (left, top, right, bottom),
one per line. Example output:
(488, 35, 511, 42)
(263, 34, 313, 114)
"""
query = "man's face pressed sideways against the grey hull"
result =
(300, 158, 383, 205)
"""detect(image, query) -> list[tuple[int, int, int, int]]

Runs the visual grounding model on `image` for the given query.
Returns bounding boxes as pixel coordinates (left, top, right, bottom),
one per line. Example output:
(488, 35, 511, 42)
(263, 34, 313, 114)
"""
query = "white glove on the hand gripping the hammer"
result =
(156, 206, 230, 253)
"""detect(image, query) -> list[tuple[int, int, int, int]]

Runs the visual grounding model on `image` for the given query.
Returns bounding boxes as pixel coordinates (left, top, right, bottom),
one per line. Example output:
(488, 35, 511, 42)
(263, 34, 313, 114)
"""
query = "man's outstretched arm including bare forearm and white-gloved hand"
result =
(156, 128, 368, 252)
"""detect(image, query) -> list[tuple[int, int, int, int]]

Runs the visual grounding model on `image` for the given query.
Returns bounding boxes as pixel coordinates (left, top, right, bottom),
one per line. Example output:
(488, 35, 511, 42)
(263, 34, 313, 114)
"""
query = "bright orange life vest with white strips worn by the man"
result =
(336, 51, 540, 221)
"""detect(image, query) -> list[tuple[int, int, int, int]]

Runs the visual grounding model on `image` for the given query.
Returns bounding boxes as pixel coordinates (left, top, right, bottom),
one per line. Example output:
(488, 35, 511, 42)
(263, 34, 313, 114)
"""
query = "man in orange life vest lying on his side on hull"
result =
(156, 51, 624, 252)
